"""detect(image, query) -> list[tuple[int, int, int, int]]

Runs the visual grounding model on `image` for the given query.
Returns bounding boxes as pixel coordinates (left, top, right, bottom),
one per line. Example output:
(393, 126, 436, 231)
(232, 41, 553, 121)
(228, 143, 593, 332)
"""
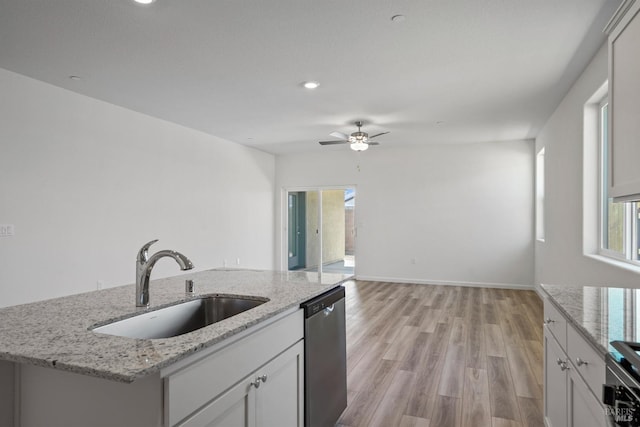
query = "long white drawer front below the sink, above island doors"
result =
(164, 310, 304, 426)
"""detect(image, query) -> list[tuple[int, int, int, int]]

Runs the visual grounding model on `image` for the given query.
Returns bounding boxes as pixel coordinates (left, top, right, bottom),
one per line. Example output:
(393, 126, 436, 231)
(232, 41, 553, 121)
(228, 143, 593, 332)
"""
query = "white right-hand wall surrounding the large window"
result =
(535, 44, 640, 287)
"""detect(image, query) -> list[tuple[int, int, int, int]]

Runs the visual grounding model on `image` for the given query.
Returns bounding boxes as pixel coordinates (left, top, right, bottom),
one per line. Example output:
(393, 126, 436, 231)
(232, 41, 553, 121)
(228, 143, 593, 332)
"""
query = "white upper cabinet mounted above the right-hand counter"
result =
(605, 0, 640, 201)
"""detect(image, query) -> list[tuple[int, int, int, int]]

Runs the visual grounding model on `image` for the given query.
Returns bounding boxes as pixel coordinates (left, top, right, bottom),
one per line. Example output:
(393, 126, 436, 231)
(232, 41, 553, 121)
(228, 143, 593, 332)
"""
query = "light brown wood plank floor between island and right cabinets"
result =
(337, 281, 544, 427)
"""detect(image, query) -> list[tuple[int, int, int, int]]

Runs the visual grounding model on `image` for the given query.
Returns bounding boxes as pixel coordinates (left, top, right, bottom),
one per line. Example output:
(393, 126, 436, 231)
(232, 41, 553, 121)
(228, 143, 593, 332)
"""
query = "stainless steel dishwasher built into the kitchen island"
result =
(301, 286, 347, 427)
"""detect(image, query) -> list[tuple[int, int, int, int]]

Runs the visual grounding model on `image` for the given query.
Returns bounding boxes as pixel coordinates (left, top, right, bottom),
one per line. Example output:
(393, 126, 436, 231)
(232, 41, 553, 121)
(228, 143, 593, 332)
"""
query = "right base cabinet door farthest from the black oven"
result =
(544, 327, 567, 427)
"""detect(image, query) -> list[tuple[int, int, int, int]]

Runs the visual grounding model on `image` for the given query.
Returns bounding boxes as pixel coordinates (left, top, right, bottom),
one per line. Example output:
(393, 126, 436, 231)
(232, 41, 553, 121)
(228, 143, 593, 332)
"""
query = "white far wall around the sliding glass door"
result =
(276, 141, 534, 286)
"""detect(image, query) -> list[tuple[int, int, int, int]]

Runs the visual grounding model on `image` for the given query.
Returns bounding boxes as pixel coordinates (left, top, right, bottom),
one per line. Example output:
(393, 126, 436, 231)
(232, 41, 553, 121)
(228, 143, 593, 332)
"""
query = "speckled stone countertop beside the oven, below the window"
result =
(542, 285, 640, 355)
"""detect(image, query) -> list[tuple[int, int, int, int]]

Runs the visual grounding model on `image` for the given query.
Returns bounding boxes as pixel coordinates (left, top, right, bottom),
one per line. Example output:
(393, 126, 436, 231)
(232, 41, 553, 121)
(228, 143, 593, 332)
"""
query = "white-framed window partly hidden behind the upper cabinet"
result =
(599, 99, 640, 262)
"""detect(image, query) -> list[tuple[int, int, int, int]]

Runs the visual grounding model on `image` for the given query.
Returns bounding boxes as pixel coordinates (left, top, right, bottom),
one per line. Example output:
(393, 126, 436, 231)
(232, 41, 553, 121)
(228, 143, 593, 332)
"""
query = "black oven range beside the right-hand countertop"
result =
(602, 341, 640, 427)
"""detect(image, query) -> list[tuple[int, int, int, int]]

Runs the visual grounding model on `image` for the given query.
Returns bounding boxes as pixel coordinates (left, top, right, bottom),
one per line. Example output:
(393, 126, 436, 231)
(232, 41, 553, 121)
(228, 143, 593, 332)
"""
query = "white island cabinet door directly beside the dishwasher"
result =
(256, 341, 304, 427)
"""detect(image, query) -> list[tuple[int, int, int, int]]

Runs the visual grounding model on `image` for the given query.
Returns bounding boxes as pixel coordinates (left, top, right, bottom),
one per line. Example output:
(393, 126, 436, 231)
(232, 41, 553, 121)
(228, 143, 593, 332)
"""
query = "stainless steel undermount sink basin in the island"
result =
(92, 295, 269, 339)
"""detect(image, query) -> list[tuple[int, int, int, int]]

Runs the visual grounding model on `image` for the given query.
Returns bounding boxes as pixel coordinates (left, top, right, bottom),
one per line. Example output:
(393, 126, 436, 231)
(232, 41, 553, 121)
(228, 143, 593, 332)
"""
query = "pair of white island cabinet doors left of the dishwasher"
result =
(178, 342, 304, 427)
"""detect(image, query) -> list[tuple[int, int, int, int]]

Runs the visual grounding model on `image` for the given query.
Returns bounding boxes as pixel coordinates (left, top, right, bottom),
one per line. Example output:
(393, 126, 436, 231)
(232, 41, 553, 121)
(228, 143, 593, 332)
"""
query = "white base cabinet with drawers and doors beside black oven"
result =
(544, 301, 606, 427)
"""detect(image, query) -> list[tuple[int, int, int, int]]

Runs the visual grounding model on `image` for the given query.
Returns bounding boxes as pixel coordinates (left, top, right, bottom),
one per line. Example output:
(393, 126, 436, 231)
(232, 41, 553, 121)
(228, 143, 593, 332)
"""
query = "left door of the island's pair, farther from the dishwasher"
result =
(178, 376, 257, 427)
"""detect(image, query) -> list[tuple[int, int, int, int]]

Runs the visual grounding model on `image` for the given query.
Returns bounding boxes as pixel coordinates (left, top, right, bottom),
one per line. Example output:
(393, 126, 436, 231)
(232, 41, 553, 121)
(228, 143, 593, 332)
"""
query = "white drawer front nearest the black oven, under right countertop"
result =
(567, 325, 606, 396)
